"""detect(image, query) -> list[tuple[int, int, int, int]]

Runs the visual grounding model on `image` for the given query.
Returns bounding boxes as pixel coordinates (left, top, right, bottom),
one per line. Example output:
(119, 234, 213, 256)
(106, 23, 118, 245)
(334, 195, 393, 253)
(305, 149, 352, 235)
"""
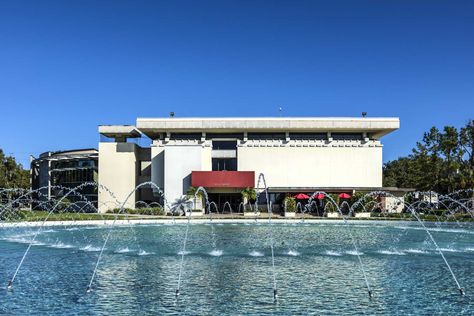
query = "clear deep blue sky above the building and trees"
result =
(0, 0, 474, 168)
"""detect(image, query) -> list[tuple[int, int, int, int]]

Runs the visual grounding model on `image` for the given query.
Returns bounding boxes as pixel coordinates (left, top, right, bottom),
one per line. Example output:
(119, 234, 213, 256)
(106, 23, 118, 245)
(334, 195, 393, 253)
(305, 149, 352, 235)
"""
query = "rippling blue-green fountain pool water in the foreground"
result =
(0, 222, 474, 315)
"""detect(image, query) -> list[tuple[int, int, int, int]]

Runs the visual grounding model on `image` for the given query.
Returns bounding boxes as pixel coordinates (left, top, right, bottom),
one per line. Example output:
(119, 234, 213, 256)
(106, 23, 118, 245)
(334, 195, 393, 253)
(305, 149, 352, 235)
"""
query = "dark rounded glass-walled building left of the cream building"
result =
(31, 148, 99, 211)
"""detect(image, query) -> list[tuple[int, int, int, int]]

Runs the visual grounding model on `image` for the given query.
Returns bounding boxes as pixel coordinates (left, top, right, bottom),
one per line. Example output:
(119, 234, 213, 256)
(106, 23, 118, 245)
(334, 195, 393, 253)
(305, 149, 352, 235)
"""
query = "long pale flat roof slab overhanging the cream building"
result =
(136, 117, 400, 138)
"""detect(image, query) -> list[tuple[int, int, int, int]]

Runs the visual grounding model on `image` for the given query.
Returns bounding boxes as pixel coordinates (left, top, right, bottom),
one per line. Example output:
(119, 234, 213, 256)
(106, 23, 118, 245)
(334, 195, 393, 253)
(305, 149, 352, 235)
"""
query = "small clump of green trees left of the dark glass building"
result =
(0, 149, 30, 189)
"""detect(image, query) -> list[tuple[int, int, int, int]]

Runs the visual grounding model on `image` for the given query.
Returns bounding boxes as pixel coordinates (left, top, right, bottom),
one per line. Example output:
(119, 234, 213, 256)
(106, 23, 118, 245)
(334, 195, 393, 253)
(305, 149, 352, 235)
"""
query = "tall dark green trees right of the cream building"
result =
(383, 120, 474, 193)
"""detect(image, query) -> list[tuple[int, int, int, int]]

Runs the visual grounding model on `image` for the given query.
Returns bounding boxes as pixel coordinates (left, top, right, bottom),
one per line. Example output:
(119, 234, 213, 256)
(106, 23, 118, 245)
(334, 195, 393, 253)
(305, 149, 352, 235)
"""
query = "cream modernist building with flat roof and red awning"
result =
(99, 117, 400, 211)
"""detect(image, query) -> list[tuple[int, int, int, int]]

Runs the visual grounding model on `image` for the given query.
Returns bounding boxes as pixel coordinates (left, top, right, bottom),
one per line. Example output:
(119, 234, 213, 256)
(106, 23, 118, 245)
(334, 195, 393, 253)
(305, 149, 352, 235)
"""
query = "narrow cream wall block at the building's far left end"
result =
(98, 143, 139, 213)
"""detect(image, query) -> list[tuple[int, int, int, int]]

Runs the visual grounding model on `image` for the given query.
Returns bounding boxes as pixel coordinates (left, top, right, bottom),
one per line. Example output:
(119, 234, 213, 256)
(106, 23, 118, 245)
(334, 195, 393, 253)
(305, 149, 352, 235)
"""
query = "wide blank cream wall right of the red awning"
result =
(237, 146, 382, 187)
